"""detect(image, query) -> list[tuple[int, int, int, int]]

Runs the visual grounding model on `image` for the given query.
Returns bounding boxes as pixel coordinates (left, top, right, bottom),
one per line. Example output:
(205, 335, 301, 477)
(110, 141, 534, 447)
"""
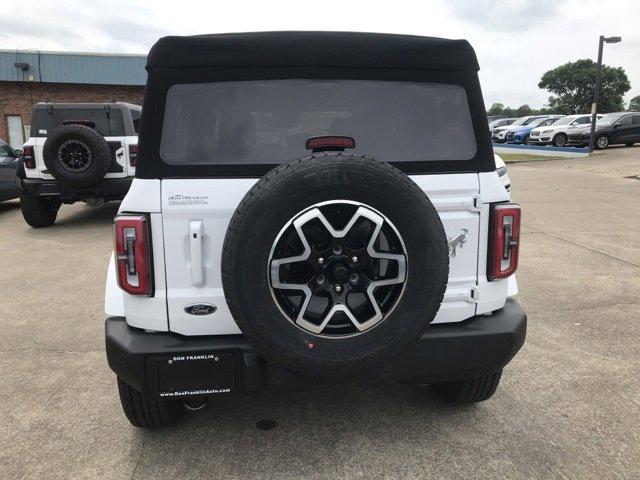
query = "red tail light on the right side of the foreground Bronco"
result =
(487, 203, 520, 280)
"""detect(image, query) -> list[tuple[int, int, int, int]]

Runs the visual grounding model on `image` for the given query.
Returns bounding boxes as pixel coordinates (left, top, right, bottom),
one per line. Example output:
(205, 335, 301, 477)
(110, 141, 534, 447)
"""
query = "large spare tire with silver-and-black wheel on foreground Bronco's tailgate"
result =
(222, 153, 449, 375)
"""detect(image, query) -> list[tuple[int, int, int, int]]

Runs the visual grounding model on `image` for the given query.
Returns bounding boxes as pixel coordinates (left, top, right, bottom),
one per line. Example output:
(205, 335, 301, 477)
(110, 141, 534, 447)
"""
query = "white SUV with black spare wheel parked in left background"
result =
(17, 102, 141, 228)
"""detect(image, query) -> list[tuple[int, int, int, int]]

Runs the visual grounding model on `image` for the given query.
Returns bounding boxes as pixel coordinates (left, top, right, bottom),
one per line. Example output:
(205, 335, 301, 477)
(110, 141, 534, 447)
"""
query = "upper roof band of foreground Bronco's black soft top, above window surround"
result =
(147, 32, 478, 71)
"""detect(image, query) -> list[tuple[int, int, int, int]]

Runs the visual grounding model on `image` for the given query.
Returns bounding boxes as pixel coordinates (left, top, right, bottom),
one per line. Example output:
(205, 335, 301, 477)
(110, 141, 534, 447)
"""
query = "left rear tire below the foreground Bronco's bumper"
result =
(118, 378, 182, 428)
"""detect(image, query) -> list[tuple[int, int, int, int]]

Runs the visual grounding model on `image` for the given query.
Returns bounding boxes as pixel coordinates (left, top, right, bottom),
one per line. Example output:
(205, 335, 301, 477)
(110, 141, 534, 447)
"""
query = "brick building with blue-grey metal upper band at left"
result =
(0, 50, 147, 148)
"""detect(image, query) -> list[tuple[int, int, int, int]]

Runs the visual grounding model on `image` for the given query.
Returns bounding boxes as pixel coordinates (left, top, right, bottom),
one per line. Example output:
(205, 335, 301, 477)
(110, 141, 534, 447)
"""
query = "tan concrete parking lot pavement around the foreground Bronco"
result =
(0, 146, 640, 479)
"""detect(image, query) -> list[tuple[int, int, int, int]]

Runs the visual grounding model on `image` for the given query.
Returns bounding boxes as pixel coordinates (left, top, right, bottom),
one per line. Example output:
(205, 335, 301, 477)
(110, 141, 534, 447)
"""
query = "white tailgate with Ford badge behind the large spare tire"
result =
(161, 173, 481, 335)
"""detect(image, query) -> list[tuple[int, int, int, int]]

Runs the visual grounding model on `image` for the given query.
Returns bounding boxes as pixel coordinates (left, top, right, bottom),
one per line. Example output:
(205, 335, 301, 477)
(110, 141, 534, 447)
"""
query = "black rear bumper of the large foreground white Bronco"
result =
(106, 299, 527, 398)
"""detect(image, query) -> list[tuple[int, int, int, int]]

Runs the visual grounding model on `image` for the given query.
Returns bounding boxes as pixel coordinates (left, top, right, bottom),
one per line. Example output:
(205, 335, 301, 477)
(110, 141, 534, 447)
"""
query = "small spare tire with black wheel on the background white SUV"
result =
(43, 125, 111, 187)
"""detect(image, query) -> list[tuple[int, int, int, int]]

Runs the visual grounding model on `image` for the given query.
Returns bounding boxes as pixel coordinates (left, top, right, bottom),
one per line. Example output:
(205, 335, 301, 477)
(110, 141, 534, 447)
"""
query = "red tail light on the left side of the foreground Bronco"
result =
(113, 215, 153, 296)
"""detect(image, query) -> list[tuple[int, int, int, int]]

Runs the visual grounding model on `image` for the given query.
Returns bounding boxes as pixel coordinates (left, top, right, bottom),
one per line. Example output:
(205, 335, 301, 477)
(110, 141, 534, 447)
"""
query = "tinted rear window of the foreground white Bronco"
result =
(160, 80, 477, 165)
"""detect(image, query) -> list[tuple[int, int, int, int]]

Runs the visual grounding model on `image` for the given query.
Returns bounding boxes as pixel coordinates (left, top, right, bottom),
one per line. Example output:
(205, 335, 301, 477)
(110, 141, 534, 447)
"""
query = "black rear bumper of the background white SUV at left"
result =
(16, 177, 133, 202)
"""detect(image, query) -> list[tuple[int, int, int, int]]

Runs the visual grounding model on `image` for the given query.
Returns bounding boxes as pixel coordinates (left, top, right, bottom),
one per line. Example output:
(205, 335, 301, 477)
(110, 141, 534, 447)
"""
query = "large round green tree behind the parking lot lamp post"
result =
(538, 59, 631, 115)
